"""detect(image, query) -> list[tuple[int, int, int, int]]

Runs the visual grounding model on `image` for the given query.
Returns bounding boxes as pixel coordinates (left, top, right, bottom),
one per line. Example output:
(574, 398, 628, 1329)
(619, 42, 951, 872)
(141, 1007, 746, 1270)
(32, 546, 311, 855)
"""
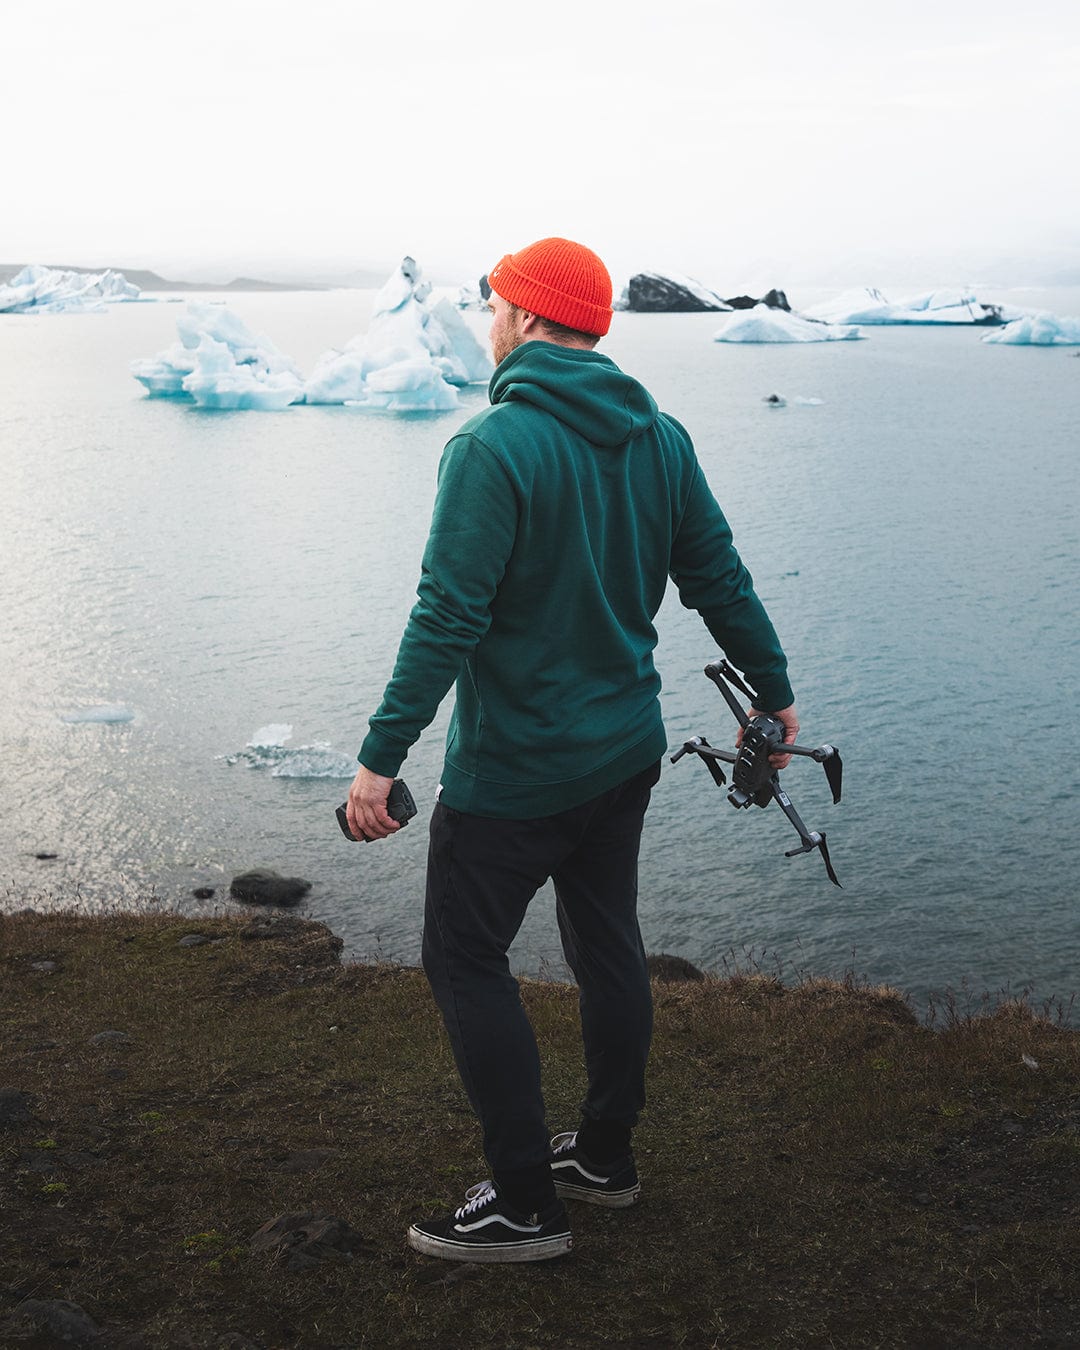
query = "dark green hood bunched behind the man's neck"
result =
(487, 342, 656, 447)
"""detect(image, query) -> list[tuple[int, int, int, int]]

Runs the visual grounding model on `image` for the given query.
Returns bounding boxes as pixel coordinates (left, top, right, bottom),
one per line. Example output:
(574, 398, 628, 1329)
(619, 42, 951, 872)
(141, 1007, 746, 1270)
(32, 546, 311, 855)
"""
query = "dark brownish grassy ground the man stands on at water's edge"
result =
(0, 914, 1080, 1350)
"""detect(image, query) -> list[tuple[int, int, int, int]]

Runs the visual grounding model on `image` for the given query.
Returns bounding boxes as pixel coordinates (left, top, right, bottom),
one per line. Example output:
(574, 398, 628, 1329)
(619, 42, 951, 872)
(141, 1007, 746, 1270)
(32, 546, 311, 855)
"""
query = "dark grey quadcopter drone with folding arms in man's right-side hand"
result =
(671, 659, 844, 886)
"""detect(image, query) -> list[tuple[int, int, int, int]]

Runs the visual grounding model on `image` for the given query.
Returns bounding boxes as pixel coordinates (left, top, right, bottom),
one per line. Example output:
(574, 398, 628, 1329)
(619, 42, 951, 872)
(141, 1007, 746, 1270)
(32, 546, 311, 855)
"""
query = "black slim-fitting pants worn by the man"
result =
(424, 764, 660, 1180)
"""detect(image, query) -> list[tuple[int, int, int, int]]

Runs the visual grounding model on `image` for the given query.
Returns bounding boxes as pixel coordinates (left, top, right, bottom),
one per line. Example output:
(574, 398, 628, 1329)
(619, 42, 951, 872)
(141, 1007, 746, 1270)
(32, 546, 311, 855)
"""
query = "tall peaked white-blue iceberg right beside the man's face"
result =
(304, 258, 494, 412)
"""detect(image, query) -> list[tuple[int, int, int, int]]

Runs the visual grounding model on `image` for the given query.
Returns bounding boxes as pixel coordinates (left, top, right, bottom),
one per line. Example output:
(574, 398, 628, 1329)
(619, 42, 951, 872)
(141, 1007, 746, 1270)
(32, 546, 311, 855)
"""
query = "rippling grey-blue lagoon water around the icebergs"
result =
(0, 293, 1080, 1000)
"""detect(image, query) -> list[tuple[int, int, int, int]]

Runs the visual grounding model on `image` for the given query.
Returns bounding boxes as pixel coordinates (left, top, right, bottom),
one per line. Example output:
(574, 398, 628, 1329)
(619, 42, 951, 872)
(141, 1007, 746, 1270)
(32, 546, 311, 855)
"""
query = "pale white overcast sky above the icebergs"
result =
(8, 0, 1080, 289)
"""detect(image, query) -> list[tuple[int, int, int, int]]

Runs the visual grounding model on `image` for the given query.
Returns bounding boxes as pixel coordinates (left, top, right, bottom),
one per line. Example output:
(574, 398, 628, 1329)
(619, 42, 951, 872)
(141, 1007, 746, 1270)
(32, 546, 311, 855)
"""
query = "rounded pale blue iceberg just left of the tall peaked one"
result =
(131, 300, 304, 412)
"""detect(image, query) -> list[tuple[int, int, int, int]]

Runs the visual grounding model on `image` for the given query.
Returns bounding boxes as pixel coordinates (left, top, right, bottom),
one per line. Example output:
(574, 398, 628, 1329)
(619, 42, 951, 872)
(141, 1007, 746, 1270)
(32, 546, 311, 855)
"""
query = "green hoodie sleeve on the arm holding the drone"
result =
(671, 462, 795, 711)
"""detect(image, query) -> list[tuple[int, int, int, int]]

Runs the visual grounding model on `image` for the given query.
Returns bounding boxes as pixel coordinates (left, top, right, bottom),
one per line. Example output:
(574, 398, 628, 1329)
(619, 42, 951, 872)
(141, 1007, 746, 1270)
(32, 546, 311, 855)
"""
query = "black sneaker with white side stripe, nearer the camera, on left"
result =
(409, 1181, 574, 1261)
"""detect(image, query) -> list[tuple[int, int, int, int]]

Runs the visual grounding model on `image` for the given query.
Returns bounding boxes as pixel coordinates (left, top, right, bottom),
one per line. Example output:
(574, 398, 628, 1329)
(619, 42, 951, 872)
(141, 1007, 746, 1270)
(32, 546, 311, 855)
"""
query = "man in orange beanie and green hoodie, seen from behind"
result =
(348, 239, 798, 1261)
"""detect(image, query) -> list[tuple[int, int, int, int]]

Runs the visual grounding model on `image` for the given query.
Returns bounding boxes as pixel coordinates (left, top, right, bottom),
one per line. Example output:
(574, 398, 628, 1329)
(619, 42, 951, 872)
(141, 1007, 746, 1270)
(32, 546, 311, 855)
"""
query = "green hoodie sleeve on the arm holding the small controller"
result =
(358, 433, 518, 778)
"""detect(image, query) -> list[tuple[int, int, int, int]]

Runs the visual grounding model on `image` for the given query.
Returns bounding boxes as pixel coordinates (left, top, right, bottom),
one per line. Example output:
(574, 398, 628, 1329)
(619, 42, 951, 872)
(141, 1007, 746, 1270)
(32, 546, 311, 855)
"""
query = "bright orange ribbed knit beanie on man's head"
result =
(487, 239, 612, 338)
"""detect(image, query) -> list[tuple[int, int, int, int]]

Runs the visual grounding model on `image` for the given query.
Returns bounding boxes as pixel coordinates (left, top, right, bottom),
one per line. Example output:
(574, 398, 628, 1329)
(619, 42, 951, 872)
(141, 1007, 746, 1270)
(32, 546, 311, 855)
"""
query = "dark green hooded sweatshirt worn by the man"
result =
(359, 342, 794, 819)
